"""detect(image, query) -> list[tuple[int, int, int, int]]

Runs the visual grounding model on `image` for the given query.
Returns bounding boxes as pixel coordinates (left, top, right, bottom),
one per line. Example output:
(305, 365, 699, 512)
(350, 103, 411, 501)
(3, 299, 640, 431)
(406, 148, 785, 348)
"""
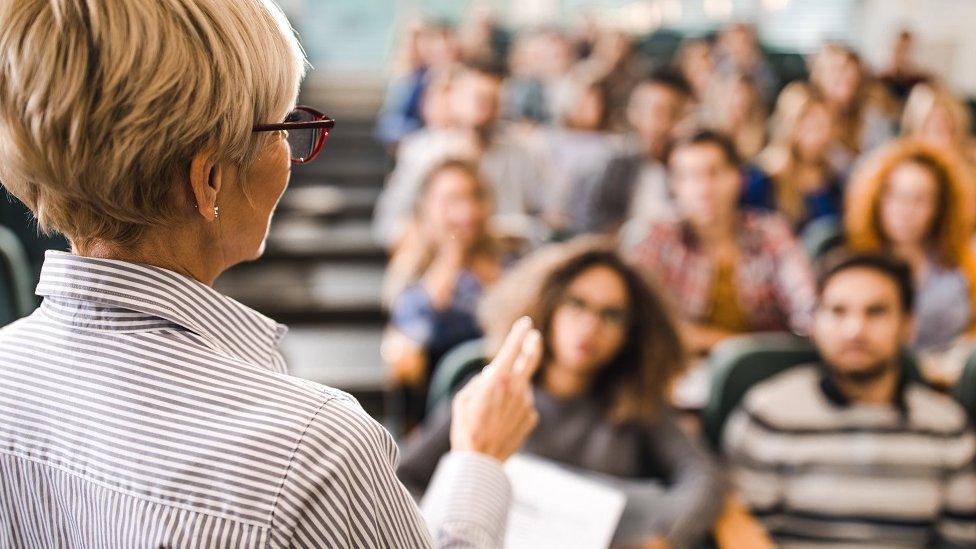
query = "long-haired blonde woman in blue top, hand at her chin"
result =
(383, 159, 503, 416)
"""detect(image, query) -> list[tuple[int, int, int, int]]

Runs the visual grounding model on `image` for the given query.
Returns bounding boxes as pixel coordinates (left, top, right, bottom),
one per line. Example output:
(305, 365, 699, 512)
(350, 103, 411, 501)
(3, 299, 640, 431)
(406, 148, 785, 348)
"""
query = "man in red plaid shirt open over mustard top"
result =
(624, 131, 814, 354)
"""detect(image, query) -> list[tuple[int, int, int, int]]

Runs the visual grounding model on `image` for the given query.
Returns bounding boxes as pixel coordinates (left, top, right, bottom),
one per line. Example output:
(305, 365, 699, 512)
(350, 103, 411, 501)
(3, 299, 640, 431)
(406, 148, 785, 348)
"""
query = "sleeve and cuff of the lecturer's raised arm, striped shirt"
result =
(273, 396, 511, 549)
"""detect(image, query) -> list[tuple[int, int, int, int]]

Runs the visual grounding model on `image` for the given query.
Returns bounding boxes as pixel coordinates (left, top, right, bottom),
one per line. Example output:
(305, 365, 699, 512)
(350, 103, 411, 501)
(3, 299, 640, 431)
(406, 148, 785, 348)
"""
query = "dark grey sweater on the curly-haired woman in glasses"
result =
(397, 388, 725, 548)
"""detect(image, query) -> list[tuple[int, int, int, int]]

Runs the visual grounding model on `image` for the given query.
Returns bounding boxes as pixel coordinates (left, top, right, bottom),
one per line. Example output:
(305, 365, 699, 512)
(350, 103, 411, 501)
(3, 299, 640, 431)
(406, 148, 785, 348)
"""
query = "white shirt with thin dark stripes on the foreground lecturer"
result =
(0, 252, 510, 549)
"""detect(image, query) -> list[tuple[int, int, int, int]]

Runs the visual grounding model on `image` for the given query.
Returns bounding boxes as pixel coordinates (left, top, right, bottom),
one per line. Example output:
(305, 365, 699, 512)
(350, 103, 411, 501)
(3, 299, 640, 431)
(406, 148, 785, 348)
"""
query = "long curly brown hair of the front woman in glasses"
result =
(479, 237, 685, 424)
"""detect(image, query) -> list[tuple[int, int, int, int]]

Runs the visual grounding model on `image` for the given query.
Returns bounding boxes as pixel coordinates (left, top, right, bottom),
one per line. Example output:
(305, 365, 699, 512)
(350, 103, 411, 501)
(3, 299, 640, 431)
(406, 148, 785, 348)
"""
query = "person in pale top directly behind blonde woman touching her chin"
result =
(373, 64, 550, 248)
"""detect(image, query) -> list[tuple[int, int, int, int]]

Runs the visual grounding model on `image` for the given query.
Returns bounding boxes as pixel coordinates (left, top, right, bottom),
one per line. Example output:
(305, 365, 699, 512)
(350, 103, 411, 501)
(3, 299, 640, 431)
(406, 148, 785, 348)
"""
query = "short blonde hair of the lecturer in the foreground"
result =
(0, 0, 306, 245)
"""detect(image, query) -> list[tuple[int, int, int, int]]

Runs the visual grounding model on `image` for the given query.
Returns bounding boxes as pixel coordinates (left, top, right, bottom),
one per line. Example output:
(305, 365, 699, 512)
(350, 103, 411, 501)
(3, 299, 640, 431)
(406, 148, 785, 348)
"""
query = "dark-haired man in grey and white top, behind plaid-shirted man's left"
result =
(574, 71, 691, 233)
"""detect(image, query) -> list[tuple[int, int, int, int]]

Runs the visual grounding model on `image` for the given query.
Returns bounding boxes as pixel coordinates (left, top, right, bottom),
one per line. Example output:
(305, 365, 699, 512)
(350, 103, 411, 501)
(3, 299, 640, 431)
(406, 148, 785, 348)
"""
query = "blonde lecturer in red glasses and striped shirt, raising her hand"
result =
(0, 0, 541, 548)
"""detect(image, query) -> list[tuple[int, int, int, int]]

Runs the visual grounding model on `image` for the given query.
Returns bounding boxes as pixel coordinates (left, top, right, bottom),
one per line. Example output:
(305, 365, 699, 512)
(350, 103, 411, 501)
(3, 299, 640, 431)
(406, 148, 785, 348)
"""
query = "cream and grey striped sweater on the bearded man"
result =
(724, 366, 976, 547)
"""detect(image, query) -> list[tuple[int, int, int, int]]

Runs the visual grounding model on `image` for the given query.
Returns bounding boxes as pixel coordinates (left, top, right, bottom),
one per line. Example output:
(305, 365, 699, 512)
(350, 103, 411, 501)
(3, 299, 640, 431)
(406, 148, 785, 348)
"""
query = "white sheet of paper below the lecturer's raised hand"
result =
(505, 455, 626, 549)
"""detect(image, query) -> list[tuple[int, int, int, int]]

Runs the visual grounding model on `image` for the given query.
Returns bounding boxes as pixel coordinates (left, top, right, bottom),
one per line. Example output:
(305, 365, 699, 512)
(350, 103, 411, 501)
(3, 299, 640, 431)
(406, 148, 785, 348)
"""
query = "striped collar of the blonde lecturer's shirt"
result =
(37, 251, 287, 366)
